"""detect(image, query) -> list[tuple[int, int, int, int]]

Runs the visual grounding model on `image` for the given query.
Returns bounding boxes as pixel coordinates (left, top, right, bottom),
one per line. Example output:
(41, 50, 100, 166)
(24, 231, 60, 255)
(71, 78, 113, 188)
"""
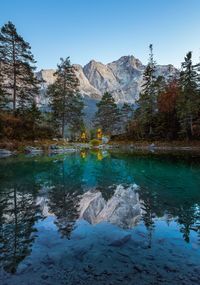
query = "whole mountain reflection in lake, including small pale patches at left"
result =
(36, 184, 144, 229)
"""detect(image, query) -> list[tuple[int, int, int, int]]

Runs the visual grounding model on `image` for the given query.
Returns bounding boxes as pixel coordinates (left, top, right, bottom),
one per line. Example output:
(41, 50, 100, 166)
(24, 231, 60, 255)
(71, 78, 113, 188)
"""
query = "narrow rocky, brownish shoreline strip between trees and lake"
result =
(0, 139, 200, 154)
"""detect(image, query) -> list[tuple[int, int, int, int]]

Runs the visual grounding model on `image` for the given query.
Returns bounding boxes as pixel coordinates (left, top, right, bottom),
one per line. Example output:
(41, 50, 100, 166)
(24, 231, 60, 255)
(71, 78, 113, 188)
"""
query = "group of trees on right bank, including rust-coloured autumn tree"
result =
(128, 45, 200, 140)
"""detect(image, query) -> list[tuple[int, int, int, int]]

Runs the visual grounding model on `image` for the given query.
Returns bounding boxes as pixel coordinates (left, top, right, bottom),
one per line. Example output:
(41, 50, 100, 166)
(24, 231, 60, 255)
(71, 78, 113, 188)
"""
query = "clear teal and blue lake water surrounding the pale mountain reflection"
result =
(0, 152, 200, 285)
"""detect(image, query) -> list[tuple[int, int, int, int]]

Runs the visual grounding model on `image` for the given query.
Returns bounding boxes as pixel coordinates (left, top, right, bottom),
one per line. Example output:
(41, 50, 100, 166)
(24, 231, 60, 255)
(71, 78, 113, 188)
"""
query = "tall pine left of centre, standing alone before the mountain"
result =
(47, 57, 84, 138)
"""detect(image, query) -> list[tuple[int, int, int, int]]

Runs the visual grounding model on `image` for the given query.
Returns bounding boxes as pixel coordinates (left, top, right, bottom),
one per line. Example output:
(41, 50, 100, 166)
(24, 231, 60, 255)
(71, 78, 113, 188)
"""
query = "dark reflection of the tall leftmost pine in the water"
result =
(0, 185, 40, 273)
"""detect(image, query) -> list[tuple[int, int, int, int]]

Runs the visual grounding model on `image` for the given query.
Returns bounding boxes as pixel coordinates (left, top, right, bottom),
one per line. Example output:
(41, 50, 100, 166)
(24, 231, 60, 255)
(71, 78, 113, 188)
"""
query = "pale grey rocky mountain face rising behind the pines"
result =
(37, 55, 178, 105)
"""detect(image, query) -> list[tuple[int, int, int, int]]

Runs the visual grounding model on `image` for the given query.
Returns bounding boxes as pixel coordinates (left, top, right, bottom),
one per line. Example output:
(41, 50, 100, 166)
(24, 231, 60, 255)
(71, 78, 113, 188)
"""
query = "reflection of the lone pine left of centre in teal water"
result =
(48, 155, 84, 239)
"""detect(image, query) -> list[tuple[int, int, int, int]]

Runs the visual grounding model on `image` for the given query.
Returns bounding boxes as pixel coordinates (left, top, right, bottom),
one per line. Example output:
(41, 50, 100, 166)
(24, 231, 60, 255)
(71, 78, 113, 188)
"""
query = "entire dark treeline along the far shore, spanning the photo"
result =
(0, 22, 200, 140)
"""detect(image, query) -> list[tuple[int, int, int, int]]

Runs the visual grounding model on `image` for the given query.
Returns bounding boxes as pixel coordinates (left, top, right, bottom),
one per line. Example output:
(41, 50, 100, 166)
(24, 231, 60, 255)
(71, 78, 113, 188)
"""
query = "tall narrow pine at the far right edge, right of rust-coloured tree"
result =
(177, 51, 200, 139)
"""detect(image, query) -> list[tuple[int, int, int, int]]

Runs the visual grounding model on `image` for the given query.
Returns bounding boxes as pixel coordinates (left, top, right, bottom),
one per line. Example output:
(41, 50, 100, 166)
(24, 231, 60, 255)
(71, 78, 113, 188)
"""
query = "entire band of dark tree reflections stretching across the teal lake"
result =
(0, 152, 200, 273)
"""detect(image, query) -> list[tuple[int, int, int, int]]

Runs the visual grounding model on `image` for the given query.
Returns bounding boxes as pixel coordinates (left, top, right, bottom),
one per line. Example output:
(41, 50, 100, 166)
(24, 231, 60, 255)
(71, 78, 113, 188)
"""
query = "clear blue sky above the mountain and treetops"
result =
(0, 0, 200, 69)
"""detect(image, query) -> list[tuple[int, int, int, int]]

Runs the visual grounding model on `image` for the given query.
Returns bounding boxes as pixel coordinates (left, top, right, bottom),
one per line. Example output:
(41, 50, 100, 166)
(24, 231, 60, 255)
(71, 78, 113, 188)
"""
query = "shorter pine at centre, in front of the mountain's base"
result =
(95, 92, 120, 135)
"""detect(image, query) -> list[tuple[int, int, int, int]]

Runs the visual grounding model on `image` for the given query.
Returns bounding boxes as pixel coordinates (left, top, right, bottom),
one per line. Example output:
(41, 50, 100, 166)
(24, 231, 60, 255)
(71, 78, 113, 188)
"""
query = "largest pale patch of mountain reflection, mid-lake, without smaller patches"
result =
(79, 184, 142, 228)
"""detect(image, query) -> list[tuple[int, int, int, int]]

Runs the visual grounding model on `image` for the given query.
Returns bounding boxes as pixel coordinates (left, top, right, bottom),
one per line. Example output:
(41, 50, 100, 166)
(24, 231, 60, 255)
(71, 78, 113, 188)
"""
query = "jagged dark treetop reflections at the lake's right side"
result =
(139, 183, 200, 243)
